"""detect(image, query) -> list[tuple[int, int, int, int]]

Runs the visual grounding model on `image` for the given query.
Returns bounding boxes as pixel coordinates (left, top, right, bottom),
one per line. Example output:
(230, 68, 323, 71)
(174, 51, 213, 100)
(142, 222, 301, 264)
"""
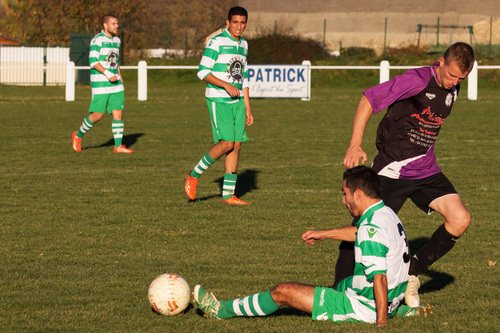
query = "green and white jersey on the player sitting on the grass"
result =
(346, 201, 410, 322)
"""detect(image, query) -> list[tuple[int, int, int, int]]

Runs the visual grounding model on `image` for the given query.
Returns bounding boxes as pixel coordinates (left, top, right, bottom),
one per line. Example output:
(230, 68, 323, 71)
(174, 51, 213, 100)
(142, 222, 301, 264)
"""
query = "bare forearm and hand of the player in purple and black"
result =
(344, 95, 373, 168)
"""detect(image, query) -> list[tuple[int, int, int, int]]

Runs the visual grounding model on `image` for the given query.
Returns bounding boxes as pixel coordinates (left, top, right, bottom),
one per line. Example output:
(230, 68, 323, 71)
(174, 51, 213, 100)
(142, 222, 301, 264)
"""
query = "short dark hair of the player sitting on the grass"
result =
(343, 165, 380, 199)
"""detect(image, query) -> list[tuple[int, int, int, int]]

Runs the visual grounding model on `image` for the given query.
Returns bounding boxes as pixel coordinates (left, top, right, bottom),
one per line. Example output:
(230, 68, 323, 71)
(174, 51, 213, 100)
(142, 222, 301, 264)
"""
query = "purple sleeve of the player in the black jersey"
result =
(363, 67, 433, 113)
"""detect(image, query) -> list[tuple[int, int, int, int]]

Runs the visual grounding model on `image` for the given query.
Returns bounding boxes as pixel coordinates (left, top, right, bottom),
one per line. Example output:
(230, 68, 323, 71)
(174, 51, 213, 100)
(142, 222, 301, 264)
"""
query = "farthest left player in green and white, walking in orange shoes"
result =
(72, 14, 134, 154)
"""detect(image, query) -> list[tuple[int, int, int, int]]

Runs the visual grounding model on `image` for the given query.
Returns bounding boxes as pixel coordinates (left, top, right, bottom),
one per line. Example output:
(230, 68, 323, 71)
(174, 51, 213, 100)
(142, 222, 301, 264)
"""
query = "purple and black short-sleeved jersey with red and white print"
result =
(363, 62, 460, 179)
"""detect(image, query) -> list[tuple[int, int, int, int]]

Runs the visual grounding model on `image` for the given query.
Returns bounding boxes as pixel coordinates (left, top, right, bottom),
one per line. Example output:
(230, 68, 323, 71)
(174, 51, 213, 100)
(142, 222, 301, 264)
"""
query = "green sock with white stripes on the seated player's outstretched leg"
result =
(217, 291, 280, 319)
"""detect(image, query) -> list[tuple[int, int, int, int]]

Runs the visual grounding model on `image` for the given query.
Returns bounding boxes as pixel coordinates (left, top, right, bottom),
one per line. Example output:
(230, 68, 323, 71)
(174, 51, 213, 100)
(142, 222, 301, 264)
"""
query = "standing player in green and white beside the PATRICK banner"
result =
(184, 7, 253, 205)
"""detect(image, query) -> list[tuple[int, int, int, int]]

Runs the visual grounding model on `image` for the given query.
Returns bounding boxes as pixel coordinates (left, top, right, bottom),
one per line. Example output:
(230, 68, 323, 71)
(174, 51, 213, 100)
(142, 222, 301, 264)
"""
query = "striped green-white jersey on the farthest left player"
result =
(89, 31, 124, 95)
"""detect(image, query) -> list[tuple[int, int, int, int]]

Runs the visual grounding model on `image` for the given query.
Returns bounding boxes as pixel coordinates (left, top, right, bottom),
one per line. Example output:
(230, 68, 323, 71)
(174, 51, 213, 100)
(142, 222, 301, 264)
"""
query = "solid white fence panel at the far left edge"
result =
(0, 46, 70, 85)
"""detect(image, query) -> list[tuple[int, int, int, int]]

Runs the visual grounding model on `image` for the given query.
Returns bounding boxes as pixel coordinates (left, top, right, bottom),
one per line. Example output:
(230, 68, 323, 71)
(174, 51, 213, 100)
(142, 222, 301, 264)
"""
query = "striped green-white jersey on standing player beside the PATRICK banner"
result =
(198, 29, 248, 103)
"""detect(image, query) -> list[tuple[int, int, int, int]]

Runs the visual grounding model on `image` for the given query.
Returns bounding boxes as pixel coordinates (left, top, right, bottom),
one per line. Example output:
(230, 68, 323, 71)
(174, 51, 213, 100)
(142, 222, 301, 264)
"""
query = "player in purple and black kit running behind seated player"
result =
(334, 43, 475, 307)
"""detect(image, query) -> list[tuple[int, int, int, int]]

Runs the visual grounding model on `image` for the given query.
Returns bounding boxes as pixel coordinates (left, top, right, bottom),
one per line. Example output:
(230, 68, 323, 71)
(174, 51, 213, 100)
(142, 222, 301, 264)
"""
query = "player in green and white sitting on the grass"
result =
(194, 166, 432, 326)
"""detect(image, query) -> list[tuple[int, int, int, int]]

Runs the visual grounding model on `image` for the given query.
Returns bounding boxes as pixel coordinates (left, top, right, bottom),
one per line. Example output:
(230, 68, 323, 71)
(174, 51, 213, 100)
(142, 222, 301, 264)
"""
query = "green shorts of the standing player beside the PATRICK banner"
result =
(207, 99, 248, 143)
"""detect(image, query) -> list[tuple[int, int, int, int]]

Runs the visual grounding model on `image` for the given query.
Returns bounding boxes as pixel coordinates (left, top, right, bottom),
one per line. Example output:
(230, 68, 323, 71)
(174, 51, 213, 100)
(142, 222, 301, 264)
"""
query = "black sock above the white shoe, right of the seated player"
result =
(408, 224, 460, 276)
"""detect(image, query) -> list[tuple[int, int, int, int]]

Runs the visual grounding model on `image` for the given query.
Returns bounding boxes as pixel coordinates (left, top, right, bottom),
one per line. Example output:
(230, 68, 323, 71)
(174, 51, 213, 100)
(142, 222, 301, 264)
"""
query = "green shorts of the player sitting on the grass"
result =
(312, 287, 359, 321)
